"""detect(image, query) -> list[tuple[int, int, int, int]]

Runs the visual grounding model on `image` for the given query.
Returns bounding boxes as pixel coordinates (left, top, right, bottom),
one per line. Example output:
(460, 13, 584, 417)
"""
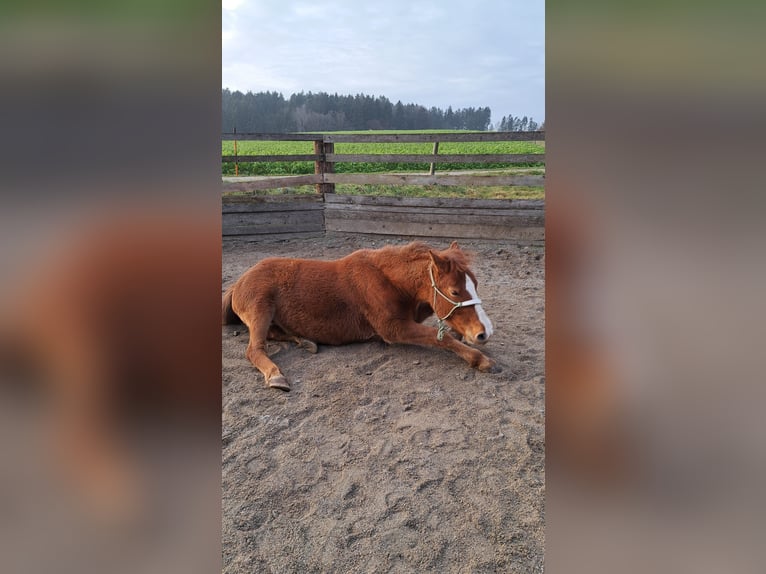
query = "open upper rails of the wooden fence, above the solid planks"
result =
(221, 131, 545, 194)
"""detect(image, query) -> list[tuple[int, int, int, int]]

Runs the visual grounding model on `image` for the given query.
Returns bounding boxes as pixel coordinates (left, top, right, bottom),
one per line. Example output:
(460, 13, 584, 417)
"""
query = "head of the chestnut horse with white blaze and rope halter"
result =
(429, 241, 492, 345)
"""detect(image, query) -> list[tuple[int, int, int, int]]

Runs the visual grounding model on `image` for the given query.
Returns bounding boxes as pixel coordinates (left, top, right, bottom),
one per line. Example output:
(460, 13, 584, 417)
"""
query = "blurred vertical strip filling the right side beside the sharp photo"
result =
(546, 3, 766, 574)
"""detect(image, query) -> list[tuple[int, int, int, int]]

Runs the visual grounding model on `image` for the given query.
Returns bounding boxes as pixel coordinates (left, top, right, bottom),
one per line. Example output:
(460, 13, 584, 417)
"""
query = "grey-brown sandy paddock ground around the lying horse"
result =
(222, 234, 545, 574)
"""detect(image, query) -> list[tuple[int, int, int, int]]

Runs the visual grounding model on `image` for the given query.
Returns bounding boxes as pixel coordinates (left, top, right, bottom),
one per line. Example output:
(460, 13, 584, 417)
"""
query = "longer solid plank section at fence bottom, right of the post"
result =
(325, 194, 545, 243)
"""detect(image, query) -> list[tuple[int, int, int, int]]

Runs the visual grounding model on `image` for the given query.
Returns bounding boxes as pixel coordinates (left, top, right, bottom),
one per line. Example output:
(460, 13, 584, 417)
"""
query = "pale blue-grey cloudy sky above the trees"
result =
(222, 0, 545, 127)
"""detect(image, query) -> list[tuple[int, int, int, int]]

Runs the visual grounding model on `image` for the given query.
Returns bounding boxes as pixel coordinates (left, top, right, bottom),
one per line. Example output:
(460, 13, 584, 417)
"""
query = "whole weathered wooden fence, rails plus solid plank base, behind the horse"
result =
(222, 132, 545, 243)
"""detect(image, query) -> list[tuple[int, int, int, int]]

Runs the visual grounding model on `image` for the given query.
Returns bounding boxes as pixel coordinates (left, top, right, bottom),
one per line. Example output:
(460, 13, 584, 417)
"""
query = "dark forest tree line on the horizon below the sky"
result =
(222, 88, 537, 133)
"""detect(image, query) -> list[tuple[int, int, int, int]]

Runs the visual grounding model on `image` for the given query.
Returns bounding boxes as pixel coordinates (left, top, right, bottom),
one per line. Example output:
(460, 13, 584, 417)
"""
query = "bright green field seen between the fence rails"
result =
(221, 130, 545, 198)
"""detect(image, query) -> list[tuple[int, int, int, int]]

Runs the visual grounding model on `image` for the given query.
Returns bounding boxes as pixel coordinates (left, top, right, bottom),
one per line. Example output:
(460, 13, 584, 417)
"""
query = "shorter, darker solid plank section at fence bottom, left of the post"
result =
(222, 195, 325, 238)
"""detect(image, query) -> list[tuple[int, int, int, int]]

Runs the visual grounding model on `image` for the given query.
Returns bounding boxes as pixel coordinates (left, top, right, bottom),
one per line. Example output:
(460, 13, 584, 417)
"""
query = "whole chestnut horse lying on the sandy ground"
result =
(222, 238, 494, 391)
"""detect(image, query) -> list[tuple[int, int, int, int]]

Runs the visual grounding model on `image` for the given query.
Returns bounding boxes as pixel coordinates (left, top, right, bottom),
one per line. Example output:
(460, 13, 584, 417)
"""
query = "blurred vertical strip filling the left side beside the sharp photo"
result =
(0, 2, 220, 573)
